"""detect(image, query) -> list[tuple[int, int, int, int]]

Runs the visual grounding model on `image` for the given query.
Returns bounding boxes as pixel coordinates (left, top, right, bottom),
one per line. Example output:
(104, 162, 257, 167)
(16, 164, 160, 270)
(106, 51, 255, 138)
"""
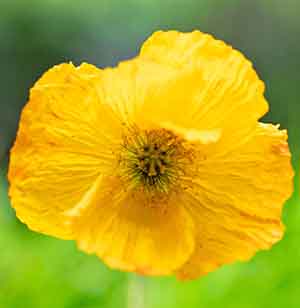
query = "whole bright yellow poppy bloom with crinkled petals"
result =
(9, 31, 293, 279)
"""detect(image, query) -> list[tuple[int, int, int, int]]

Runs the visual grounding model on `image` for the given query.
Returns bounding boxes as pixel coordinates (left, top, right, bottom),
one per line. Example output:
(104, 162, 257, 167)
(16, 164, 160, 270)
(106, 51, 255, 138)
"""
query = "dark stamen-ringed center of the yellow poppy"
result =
(121, 129, 190, 192)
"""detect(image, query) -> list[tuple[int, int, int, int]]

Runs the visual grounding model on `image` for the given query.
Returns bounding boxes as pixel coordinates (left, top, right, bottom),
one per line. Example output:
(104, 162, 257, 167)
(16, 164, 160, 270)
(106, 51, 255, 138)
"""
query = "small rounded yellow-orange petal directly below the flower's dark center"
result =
(73, 178, 194, 275)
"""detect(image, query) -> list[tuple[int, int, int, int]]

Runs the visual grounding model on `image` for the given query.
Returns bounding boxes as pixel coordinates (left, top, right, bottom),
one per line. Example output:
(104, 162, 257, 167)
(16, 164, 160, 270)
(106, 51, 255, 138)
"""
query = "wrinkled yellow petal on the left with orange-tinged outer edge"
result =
(9, 64, 121, 238)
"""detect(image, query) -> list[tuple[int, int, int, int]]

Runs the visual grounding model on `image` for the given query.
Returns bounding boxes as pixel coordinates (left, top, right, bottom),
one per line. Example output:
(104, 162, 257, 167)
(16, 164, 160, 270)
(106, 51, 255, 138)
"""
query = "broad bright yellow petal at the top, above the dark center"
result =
(99, 31, 268, 140)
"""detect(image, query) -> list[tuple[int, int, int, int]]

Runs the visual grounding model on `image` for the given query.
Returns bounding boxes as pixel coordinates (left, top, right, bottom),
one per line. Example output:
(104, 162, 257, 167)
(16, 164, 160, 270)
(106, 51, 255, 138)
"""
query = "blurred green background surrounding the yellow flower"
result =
(0, 0, 300, 308)
